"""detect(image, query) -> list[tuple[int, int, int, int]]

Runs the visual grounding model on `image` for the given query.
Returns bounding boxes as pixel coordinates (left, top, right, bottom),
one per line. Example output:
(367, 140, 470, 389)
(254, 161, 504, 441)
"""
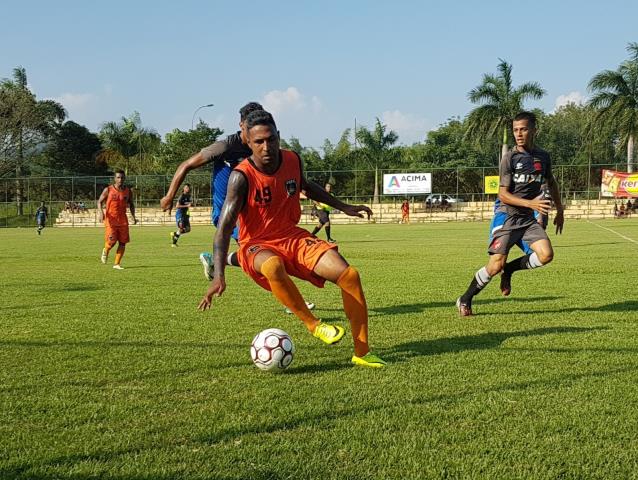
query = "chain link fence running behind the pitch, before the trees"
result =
(0, 163, 624, 227)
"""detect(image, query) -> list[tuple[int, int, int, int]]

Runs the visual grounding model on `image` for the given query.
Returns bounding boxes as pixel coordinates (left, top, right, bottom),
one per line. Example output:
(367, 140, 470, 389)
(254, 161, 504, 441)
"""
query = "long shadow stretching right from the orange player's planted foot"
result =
(382, 327, 608, 362)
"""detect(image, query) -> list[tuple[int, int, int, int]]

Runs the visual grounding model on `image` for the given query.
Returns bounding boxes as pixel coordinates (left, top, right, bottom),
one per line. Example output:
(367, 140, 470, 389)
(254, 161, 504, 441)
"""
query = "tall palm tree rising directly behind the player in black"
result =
(466, 58, 545, 161)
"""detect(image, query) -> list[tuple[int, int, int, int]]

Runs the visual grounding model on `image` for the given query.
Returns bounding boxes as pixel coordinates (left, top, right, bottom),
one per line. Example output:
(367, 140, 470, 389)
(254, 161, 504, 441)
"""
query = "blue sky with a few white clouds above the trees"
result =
(0, 0, 638, 147)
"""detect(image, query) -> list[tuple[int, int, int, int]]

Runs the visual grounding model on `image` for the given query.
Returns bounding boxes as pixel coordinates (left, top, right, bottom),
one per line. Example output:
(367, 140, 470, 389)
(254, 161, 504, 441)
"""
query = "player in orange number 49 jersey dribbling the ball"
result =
(199, 111, 385, 368)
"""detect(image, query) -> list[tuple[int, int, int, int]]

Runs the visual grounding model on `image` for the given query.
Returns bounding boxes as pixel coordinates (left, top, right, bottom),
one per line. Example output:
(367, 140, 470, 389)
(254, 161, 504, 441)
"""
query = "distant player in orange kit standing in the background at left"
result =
(97, 170, 137, 270)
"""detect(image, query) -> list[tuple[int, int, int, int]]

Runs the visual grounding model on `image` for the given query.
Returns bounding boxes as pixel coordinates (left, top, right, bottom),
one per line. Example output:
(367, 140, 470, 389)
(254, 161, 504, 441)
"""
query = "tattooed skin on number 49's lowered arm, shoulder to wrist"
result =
(213, 171, 248, 277)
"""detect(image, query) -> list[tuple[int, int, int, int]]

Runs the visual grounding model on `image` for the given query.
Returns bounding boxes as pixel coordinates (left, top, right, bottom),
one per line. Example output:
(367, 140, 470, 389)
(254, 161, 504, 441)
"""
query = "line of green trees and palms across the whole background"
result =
(0, 43, 638, 209)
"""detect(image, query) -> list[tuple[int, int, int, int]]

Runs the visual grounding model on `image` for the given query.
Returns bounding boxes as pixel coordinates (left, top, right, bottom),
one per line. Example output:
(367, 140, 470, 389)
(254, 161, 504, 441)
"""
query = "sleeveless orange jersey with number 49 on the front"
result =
(235, 150, 301, 243)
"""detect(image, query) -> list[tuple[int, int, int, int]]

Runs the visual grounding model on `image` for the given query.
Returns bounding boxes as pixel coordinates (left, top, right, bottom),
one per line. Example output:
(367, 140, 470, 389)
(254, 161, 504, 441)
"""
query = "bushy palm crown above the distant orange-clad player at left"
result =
(99, 112, 162, 175)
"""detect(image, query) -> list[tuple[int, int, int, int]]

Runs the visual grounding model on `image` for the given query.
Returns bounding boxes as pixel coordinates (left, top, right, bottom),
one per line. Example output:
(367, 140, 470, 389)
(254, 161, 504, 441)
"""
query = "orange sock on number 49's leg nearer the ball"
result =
(261, 256, 320, 333)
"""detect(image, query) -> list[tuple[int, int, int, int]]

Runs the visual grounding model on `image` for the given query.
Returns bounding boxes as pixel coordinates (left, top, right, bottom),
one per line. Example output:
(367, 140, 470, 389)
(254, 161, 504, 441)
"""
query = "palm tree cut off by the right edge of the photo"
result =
(588, 42, 638, 172)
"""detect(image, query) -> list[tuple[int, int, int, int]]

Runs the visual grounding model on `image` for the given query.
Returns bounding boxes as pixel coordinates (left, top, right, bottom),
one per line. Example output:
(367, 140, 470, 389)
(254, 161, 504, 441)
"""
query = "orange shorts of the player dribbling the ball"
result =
(237, 227, 337, 291)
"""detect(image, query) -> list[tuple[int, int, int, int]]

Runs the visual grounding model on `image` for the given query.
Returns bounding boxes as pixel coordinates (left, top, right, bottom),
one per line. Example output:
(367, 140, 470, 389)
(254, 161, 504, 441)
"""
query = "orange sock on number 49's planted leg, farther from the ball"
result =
(337, 267, 370, 357)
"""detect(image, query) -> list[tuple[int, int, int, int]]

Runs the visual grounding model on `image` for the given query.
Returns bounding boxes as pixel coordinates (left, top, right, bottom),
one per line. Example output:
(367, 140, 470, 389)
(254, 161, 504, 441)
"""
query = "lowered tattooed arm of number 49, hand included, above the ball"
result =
(198, 171, 248, 310)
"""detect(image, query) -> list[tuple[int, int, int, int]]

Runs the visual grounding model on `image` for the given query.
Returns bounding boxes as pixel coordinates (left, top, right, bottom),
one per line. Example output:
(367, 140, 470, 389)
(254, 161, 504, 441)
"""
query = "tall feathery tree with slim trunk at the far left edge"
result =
(0, 67, 66, 215)
